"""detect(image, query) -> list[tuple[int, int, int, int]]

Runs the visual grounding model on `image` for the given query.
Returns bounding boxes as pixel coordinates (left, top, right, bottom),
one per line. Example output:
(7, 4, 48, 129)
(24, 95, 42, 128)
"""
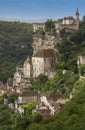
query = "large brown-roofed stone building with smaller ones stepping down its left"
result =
(13, 48, 56, 87)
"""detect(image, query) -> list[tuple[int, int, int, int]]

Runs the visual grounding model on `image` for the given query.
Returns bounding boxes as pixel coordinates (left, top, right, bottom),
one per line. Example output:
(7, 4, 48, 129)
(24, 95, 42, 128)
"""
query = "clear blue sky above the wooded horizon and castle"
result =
(0, 0, 85, 21)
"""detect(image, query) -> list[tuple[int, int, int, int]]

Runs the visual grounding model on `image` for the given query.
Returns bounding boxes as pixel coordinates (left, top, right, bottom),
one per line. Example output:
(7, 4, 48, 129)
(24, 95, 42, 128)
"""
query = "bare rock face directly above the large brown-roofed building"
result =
(33, 33, 58, 54)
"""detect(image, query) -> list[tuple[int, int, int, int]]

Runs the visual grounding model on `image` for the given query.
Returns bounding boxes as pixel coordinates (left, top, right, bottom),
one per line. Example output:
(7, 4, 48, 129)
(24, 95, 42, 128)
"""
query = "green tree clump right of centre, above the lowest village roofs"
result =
(43, 70, 79, 97)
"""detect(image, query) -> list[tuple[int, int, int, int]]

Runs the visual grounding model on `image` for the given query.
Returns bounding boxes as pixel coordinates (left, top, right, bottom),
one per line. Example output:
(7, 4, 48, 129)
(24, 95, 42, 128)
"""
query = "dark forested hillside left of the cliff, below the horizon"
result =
(0, 21, 33, 82)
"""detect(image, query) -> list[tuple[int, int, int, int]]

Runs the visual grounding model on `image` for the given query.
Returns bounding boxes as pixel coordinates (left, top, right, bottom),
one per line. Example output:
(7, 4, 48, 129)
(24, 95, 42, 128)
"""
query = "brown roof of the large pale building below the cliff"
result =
(33, 49, 55, 58)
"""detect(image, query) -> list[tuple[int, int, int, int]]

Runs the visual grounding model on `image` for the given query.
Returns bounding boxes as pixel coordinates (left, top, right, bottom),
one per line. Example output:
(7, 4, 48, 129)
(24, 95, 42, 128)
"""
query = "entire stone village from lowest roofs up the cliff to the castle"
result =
(0, 9, 85, 116)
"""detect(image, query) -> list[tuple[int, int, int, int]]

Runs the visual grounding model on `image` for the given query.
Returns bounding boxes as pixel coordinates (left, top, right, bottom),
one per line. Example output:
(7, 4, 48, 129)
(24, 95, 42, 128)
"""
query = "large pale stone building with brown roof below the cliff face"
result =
(32, 49, 55, 77)
